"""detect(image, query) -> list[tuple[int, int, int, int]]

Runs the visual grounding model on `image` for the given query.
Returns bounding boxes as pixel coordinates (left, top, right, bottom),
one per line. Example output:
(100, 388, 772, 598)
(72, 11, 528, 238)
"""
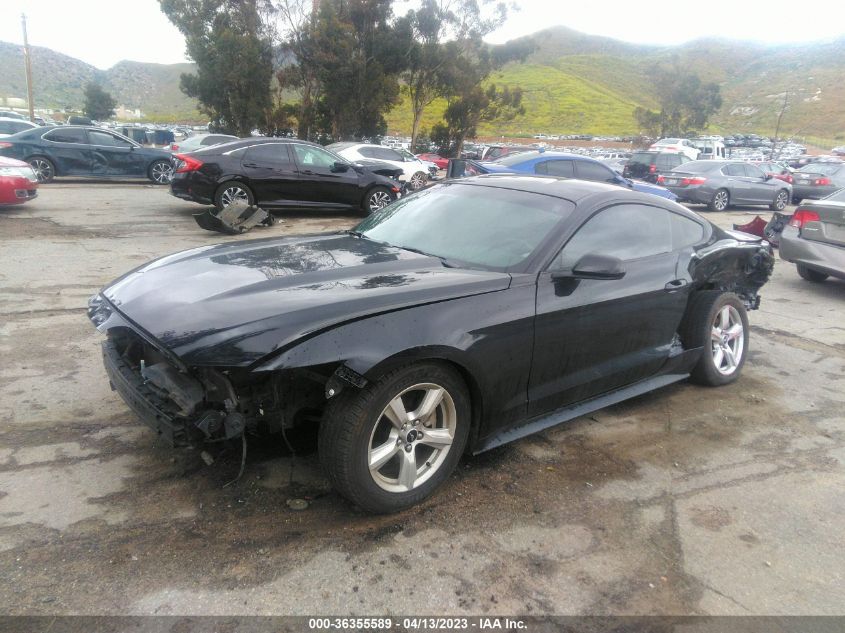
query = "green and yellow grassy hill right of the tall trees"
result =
(388, 27, 845, 140)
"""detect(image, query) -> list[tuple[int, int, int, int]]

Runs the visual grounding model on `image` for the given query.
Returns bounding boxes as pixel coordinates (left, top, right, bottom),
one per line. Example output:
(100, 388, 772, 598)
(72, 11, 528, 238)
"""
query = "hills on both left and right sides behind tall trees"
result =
(0, 27, 845, 144)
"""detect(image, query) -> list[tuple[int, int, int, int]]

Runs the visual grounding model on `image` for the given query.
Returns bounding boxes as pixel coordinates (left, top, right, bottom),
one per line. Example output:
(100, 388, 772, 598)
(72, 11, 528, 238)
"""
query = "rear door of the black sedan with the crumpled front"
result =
(241, 143, 302, 206)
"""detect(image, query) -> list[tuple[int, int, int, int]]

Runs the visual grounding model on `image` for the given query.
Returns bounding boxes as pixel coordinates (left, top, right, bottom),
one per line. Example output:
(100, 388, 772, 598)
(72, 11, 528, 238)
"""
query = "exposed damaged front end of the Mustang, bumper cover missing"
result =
(88, 295, 334, 447)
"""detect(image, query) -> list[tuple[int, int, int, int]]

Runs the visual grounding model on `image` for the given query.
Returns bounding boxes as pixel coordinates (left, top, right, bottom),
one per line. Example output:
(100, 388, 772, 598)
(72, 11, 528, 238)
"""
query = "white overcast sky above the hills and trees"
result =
(0, 0, 845, 69)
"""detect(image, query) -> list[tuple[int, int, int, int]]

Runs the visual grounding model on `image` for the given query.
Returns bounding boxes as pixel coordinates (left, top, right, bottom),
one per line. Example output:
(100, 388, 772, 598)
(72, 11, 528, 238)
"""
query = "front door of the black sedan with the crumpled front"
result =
(293, 143, 362, 208)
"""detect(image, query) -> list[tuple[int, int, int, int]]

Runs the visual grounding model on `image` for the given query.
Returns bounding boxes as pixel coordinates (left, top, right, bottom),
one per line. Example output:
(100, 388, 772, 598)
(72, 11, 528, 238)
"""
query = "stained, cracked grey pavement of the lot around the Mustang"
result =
(0, 181, 845, 615)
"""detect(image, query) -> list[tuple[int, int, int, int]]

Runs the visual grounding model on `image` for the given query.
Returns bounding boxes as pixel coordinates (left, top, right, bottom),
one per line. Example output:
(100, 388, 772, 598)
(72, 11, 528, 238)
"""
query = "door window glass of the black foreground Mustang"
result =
(552, 204, 672, 270)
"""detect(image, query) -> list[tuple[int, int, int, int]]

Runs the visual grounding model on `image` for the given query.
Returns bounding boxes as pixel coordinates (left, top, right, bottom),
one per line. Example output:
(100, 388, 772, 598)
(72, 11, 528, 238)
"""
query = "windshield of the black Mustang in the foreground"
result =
(354, 183, 573, 270)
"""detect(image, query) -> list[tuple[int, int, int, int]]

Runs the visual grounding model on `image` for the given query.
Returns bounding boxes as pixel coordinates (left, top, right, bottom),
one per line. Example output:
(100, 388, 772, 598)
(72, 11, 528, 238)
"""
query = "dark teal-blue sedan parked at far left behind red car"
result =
(0, 125, 172, 185)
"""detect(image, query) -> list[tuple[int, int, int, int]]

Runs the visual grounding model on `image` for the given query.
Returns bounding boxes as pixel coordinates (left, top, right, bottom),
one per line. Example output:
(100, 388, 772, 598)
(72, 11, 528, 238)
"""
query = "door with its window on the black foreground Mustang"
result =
(528, 203, 692, 416)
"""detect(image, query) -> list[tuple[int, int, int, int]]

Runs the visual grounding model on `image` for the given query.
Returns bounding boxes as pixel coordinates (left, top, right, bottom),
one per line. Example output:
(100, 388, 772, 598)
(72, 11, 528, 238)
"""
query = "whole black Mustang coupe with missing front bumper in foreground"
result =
(89, 176, 773, 512)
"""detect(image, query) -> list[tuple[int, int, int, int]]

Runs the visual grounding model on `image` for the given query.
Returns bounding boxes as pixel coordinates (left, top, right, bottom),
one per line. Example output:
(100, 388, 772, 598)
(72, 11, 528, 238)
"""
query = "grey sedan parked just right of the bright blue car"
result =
(657, 160, 792, 211)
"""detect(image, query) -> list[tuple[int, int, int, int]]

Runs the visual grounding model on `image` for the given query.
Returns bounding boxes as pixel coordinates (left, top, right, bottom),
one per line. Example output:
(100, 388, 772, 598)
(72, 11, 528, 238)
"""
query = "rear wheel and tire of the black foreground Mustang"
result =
(679, 290, 748, 387)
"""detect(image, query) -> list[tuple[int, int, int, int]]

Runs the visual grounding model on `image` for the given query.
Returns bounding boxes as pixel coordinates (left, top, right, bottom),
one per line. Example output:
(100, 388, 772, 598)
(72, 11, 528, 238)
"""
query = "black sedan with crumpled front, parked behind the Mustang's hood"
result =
(170, 138, 400, 213)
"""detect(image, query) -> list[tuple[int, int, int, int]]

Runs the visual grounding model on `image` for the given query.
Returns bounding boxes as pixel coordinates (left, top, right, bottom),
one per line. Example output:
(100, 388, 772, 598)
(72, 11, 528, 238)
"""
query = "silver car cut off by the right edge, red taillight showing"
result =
(780, 189, 845, 282)
